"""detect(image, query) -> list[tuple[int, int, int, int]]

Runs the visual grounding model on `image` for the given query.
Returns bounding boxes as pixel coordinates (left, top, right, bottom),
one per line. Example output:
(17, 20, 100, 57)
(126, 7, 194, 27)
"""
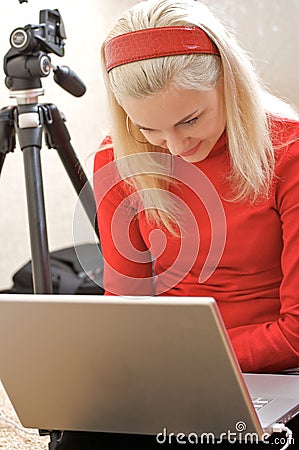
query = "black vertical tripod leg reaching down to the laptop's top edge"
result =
(23, 146, 52, 294)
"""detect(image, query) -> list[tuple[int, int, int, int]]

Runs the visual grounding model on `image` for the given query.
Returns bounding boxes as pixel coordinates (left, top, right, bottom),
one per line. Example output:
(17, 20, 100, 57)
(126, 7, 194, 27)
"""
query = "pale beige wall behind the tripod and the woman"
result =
(0, 0, 299, 289)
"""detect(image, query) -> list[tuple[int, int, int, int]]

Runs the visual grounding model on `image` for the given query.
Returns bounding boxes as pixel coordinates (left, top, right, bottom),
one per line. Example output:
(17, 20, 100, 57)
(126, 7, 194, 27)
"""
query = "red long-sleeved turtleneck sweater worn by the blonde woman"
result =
(94, 116, 299, 372)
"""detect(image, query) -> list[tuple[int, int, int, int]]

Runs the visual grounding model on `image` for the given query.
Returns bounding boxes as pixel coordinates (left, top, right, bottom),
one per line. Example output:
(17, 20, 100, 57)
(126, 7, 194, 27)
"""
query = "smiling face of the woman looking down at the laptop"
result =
(121, 87, 226, 162)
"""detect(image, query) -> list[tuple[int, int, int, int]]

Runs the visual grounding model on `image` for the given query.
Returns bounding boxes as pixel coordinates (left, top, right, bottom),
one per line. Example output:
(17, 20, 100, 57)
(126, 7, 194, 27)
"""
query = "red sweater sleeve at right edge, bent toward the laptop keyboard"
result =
(228, 134, 299, 372)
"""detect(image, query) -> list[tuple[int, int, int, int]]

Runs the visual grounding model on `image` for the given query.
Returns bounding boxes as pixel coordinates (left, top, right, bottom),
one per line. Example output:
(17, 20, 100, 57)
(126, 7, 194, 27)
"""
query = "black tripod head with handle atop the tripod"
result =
(4, 9, 86, 98)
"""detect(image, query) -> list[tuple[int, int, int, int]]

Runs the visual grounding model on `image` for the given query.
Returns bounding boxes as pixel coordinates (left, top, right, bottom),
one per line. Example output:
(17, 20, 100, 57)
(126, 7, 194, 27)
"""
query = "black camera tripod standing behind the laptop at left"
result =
(0, 10, 98, 450)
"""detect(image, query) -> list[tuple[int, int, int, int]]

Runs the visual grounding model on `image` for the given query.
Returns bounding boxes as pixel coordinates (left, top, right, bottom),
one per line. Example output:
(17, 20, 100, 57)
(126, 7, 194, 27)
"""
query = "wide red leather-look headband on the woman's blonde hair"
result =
(104, 27, 220, 72)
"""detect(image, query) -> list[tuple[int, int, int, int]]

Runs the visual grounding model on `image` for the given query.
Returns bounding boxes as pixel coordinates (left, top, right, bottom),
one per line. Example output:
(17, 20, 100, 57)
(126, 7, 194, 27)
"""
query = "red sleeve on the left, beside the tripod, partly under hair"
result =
(93, 139, 154, 295)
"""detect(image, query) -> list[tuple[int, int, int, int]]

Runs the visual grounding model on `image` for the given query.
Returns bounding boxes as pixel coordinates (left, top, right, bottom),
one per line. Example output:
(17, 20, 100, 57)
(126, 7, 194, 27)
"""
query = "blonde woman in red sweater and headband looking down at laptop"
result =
(58, 0, 299, 448)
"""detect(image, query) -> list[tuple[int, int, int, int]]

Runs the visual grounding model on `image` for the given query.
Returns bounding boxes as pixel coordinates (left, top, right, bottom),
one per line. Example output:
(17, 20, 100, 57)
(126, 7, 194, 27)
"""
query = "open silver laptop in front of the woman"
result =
(0, 294, 299, 441)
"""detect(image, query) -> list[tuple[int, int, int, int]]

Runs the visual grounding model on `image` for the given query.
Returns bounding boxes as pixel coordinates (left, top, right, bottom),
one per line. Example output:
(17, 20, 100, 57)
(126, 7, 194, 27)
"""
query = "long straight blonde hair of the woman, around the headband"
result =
(102, 0, 298, 229)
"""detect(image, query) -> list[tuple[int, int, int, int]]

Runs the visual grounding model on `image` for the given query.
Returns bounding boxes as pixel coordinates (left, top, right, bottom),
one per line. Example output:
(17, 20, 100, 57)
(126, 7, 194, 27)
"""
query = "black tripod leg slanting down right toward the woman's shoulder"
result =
(43, 104, 99, 238)
